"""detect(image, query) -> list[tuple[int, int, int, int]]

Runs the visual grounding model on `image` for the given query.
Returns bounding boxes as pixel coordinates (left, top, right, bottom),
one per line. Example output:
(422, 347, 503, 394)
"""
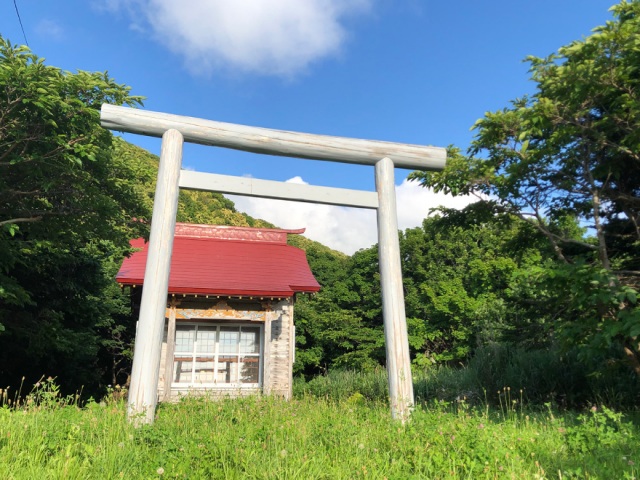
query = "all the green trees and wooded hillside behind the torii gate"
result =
(0, 1, 640, 403)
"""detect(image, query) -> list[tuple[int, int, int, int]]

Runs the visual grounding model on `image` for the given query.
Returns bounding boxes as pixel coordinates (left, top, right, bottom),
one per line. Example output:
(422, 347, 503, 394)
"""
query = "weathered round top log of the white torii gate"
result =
(100, 104, 447, 170)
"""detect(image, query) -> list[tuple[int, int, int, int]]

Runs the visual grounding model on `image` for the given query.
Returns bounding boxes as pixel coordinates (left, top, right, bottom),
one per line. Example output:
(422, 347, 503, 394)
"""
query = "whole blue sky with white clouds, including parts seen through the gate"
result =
(0, 0, 613, 253)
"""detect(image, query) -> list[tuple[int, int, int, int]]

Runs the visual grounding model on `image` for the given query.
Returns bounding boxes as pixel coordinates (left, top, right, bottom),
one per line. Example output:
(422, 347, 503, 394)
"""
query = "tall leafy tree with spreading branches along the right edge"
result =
(413, 0, 640, 375)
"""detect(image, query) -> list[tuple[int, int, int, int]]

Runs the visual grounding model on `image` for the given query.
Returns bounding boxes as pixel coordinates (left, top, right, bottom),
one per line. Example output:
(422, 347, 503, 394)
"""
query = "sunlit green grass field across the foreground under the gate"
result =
(0, 383, 640, 479)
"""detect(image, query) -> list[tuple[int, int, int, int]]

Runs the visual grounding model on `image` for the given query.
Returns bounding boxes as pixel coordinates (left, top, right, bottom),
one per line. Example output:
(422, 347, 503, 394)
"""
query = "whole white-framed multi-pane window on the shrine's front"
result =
(173, 324, 262, 386)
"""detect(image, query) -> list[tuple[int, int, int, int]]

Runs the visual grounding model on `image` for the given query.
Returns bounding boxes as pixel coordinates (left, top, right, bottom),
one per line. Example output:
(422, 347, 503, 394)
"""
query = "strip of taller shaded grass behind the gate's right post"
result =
(294, 345, 640, 409)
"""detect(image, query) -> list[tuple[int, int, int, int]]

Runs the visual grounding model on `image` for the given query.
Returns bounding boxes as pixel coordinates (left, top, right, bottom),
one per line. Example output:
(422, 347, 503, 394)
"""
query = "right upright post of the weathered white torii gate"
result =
(375, 158, 414, 422)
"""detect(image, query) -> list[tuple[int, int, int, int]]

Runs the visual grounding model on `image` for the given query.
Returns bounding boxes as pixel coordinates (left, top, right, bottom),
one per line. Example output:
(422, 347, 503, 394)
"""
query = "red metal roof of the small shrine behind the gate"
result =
(116, 224, 320, 297)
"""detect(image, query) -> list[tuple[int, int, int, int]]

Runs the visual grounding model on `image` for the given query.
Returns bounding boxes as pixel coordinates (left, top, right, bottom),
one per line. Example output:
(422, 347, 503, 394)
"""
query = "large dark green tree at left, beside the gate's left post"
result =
(0, 37, 149, 396)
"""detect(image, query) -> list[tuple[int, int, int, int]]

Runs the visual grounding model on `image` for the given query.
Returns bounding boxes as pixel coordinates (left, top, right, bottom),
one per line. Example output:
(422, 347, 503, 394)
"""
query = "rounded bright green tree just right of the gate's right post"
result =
(401, 202, 549, 363)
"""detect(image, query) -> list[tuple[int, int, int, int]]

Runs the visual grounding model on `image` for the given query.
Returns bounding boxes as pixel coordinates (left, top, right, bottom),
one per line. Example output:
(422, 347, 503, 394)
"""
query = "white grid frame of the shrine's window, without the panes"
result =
(171, 320, 265, 390)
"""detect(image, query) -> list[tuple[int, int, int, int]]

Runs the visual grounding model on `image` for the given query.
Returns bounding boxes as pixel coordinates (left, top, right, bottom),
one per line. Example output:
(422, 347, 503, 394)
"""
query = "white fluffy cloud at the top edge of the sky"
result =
(103, 0, 372, 76)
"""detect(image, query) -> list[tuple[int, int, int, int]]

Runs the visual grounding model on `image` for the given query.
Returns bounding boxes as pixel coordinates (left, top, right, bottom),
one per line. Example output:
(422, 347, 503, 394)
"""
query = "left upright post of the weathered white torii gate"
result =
(128, 130, 183, 425)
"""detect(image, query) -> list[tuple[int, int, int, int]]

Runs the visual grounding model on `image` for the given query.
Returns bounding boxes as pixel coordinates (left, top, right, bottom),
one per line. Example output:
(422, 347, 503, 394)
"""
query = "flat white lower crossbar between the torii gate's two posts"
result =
(180, 170, 378, 209)
